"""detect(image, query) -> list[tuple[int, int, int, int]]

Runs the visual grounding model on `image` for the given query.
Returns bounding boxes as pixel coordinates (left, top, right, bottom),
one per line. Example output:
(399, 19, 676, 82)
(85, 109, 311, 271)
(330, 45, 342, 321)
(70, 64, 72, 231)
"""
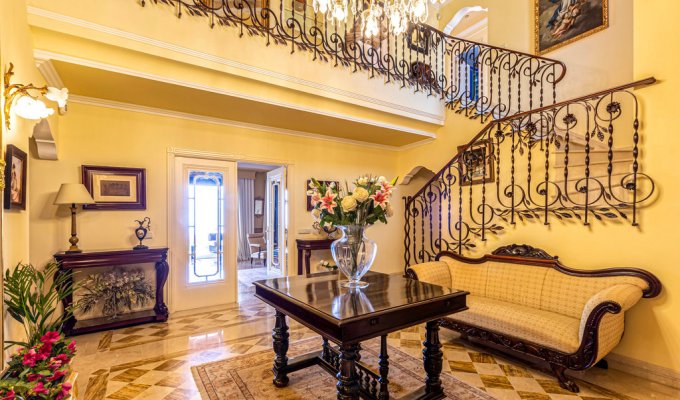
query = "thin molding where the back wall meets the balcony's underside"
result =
(69, 95, 434, 151)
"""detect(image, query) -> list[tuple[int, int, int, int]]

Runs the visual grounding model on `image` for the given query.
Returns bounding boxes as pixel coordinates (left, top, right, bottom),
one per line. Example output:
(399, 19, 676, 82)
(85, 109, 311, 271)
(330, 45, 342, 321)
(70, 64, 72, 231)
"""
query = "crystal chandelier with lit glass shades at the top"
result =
(312, 0, 442, 37)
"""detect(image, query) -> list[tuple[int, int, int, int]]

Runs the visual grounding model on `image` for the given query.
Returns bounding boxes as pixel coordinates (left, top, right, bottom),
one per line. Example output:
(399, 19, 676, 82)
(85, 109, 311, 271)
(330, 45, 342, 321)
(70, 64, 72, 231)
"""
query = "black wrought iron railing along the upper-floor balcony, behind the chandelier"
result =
(136, 0, 566, 121)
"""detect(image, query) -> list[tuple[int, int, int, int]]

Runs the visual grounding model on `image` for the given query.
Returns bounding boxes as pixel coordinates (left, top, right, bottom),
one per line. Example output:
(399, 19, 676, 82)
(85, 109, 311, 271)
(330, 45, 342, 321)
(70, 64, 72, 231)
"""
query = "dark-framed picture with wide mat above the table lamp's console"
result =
(82, 165, 146, 210)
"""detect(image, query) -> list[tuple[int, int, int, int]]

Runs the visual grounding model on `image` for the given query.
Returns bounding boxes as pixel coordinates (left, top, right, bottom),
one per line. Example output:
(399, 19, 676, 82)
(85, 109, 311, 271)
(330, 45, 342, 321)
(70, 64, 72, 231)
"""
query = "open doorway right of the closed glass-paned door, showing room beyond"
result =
(238, 162, 288, 300)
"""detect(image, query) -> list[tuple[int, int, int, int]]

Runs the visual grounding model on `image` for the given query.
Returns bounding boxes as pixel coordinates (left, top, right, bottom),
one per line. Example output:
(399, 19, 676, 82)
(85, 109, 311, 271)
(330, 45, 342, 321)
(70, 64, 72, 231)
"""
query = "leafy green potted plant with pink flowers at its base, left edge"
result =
(0, 263, 76, 400)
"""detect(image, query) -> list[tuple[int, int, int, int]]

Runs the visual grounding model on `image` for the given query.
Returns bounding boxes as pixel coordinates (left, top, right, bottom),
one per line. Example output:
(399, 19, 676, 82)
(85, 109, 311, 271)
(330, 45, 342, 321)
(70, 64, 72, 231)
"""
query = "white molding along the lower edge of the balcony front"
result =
(33, 50, 435, 143)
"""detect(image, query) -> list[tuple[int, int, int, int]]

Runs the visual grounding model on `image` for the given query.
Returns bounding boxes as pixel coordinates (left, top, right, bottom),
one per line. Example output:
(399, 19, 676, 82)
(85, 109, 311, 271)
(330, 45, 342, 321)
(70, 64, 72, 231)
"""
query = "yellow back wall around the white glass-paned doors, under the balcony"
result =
(30, 104, 402, 278)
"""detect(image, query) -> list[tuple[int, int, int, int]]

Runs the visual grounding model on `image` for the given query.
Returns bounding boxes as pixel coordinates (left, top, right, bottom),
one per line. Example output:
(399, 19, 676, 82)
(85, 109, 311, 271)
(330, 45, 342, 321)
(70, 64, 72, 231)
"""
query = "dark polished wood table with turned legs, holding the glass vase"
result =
(254, 272, 469, 400)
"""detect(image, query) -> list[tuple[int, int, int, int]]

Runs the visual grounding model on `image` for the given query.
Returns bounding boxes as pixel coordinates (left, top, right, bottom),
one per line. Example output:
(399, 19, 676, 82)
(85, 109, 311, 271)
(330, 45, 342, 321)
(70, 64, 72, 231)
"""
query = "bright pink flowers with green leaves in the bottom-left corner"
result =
(0, 331, 76, 400)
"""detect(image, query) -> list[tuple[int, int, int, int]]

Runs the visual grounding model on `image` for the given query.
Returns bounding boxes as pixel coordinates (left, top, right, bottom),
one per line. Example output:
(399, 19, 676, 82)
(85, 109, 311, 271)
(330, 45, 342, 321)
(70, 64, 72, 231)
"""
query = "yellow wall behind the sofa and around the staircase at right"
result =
(399, 0, 680, 371)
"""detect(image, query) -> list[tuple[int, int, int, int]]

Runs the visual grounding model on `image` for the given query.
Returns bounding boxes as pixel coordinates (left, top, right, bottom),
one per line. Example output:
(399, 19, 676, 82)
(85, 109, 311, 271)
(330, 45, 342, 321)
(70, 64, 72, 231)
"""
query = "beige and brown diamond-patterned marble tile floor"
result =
(75, 282, 680, 400)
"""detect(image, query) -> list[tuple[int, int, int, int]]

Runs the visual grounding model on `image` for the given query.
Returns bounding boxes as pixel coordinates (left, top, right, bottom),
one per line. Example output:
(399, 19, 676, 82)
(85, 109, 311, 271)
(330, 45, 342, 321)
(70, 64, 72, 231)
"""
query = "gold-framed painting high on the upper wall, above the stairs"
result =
(534, 0, 609, 55)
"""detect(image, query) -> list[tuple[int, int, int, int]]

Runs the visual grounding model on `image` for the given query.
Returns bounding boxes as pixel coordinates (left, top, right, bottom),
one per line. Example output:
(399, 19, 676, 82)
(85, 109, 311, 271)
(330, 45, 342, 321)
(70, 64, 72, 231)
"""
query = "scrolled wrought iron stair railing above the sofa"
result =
(404, 78, 655, 266)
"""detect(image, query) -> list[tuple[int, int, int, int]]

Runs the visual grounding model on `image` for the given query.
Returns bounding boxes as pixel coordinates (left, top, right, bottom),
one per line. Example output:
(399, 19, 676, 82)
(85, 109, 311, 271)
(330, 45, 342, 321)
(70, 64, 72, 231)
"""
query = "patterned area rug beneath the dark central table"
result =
(191, 338, 493, 400)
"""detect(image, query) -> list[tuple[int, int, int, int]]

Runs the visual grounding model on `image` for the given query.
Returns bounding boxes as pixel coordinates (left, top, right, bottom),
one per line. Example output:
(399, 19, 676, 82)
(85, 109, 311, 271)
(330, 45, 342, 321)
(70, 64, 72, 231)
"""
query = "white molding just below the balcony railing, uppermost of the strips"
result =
(27, 6, 444, 125)
